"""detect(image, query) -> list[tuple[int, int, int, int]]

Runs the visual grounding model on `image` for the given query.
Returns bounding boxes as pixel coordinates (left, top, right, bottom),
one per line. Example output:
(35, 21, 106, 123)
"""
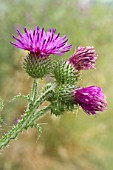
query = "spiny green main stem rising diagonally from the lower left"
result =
(0, 79, 54, 150)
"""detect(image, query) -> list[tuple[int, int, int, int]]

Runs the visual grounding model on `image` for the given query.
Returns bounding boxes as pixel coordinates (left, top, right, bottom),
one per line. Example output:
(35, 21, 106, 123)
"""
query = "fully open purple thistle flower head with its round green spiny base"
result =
(11, 27, 72, 78)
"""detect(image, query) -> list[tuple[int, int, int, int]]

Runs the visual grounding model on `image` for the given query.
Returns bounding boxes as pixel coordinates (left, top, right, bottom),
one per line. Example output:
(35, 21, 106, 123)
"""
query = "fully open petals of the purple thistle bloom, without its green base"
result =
(11, 27, 72, 57)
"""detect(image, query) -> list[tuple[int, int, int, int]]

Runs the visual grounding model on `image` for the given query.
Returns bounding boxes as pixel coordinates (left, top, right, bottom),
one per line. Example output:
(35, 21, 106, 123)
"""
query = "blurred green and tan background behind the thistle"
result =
(0, 0, 113, 170)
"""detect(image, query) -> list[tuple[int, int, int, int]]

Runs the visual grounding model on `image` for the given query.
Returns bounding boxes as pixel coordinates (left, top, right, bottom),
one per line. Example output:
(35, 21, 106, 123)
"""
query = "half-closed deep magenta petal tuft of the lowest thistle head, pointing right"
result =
(74, 86, 107, 114)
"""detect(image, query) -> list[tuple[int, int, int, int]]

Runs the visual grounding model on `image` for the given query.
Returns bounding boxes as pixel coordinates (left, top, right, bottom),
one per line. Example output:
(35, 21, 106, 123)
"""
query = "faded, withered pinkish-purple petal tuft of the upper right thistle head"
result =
(68, 46, 96, 71)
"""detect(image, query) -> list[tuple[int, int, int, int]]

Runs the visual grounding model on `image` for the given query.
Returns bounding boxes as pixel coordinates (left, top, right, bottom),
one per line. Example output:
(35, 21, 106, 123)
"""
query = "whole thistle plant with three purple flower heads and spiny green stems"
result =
(0, 27, 107, 150)
